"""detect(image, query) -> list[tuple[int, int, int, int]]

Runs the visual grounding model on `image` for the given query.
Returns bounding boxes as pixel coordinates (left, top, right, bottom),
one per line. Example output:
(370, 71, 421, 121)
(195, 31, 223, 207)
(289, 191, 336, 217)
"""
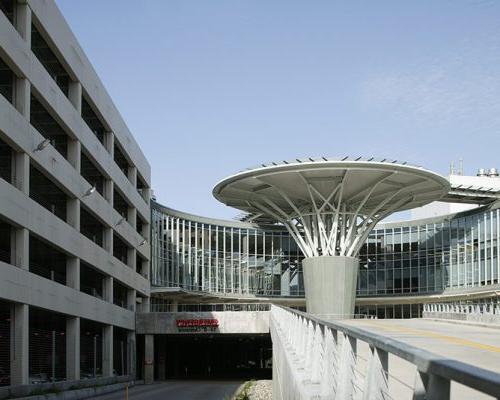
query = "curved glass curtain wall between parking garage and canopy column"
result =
(151, 208, 304, 296)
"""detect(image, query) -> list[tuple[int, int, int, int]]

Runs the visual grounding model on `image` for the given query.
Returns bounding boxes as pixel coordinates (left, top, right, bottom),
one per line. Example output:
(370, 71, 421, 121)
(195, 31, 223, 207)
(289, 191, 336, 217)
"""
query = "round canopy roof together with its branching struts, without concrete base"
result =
(213, 157, 450, 257)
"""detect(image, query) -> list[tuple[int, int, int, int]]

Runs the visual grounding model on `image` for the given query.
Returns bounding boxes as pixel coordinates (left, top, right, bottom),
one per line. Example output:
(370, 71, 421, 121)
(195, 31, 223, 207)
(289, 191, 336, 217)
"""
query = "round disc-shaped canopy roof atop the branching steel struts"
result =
(213, 157, 450, 219)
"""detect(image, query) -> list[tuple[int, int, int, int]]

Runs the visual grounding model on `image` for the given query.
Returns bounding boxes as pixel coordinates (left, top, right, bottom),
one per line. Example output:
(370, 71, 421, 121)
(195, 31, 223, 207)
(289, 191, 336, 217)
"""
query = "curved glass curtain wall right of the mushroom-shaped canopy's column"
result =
(358, 208, 500, 297)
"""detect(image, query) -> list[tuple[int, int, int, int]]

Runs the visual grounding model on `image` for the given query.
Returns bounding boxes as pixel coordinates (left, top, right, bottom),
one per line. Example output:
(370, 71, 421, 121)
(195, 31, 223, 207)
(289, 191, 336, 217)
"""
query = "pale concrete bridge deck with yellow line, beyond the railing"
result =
(342, 319, 500, 399)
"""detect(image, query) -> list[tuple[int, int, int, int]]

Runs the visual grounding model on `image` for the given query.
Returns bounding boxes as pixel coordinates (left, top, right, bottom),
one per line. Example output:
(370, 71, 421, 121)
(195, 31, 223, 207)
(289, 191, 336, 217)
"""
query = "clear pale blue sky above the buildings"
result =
(57, 0, 500, 218)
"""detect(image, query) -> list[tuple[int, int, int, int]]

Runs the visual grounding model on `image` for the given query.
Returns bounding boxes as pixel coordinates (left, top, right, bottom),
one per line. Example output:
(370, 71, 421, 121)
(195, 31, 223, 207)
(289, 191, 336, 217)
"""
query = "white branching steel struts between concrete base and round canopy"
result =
(248, 172, 422, 257)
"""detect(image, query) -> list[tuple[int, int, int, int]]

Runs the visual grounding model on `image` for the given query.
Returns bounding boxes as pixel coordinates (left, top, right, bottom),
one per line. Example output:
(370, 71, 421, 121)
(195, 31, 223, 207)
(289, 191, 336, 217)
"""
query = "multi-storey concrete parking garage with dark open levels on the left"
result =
(0, 0, 150, 390)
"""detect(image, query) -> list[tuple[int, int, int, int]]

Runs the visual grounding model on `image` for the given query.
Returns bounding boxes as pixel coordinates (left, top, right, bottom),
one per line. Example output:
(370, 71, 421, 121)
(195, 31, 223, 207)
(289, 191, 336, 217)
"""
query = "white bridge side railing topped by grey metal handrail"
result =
(271, 306, 500, 400)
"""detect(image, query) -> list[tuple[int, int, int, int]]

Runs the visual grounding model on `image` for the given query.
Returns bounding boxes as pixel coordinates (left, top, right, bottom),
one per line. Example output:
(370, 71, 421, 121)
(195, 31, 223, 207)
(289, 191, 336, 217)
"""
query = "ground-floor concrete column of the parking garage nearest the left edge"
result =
(10, 304, 29, 386)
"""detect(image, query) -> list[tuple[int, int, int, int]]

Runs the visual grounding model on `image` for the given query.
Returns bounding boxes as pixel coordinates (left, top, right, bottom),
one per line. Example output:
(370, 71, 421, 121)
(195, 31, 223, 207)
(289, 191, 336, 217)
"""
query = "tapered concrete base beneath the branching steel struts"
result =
(302, 256, 359, 319)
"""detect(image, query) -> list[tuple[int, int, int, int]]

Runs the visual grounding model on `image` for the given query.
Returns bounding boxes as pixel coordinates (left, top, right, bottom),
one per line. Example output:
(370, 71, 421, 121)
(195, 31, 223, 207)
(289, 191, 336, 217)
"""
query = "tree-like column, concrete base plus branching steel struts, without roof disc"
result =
(248, 171, 422, 319)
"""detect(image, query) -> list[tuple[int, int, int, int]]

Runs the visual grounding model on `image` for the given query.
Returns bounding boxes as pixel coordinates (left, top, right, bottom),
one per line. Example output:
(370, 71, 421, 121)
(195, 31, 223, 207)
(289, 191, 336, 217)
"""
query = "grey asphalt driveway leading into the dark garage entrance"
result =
(95, 381, 243, 400)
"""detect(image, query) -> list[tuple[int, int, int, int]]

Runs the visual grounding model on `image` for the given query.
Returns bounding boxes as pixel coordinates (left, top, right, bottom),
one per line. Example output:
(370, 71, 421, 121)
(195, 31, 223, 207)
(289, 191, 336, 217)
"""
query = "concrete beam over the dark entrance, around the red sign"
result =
(136, 311, 269, 335)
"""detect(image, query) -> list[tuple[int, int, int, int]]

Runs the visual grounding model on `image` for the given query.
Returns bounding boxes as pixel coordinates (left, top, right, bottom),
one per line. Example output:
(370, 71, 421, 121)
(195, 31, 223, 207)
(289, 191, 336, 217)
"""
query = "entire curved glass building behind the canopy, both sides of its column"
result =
(151, 202, 500, 318)
